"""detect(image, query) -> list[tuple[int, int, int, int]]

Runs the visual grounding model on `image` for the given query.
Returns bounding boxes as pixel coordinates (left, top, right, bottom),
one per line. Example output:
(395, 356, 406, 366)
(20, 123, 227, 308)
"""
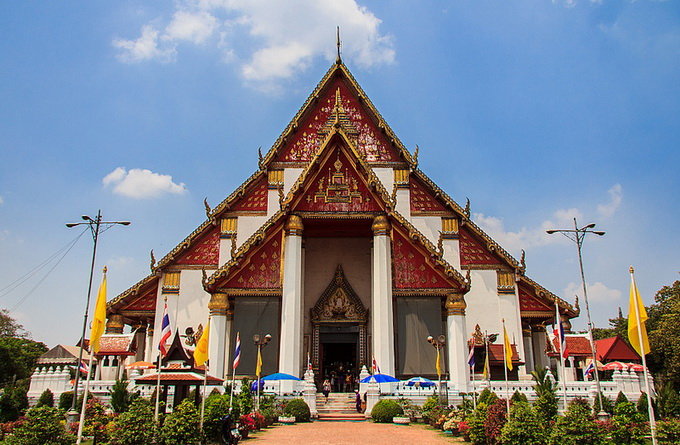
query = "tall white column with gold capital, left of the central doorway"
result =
(279, 215, 303, 377)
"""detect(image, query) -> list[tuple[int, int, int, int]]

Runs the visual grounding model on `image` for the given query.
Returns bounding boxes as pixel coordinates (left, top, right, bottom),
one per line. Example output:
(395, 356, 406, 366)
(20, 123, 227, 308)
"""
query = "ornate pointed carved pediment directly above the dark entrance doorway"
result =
(312, 265, 368, 323)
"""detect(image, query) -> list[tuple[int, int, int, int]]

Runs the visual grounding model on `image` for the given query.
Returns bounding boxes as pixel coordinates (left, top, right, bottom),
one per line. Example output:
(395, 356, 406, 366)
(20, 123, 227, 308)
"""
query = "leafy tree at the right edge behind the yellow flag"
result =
(647, 281, 680, 390)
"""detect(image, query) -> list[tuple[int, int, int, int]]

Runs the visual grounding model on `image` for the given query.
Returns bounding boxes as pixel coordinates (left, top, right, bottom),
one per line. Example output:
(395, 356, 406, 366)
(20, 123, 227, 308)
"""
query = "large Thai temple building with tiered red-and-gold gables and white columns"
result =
(107, 58, 579, 391)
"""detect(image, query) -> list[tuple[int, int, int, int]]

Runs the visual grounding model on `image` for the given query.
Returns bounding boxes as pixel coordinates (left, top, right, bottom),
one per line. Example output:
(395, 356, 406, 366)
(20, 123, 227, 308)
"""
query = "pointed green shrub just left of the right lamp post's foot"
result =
(550, 399, 607, 445)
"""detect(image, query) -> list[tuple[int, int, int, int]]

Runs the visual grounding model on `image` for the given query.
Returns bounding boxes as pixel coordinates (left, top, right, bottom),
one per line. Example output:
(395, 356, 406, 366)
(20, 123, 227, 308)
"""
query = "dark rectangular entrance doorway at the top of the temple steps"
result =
(320, 325, 359, 392)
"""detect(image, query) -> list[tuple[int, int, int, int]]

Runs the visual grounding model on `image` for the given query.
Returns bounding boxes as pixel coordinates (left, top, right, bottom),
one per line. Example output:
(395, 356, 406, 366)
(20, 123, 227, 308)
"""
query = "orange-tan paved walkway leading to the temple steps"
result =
(241, 422, 461, 445)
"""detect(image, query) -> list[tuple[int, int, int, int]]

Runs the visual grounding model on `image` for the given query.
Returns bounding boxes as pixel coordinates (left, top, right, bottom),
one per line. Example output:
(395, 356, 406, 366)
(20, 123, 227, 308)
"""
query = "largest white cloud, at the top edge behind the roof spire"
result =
(113, 0, 395, 85)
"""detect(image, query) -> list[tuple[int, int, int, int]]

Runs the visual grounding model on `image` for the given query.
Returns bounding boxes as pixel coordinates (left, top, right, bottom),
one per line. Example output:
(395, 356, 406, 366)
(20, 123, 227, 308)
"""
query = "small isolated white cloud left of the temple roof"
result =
(102, 167, 187, 199)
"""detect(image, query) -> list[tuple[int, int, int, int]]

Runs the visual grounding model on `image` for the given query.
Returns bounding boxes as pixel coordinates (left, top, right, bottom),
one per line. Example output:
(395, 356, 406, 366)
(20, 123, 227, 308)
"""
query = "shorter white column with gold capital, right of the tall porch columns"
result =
(446, 294, 470, 392)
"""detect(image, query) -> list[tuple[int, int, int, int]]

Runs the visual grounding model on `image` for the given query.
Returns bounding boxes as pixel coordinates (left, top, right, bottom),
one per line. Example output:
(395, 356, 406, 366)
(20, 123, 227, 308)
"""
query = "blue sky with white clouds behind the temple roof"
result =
(0, 0, 680, 345)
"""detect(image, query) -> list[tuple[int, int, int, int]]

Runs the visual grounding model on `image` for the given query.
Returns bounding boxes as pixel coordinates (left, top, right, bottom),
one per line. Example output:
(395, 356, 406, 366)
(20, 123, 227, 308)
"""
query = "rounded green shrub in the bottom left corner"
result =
(3, 406, 75, 445)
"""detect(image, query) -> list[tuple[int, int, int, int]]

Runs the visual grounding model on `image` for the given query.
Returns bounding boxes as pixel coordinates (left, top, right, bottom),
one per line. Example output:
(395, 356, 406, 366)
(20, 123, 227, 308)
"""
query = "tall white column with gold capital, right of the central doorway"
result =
(369, 216, 394, 376)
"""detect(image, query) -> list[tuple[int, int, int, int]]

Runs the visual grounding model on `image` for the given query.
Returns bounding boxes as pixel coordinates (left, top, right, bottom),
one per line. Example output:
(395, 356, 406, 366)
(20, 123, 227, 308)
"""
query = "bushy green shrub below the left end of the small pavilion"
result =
(107, 398, 157, 445)
